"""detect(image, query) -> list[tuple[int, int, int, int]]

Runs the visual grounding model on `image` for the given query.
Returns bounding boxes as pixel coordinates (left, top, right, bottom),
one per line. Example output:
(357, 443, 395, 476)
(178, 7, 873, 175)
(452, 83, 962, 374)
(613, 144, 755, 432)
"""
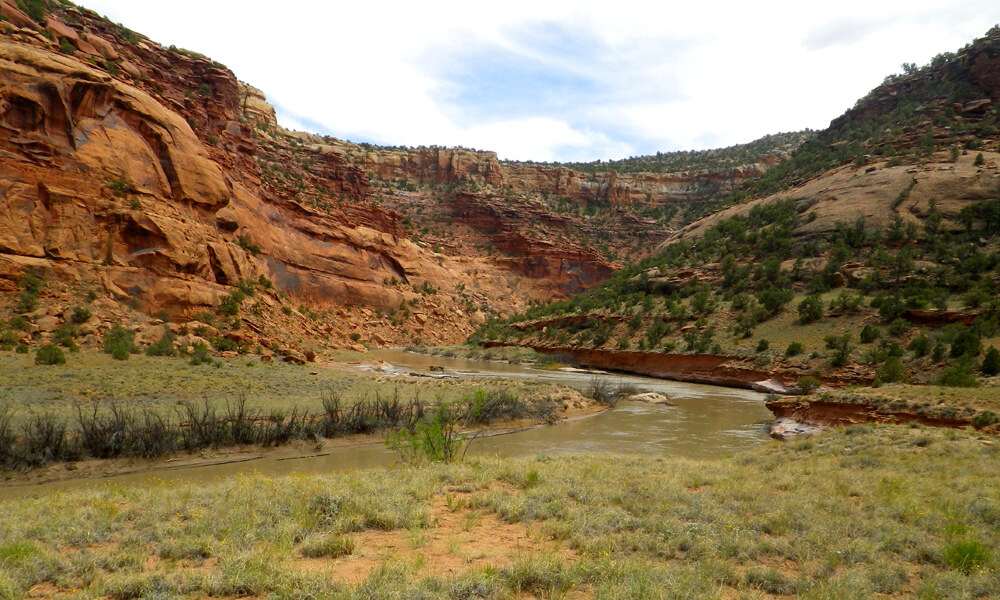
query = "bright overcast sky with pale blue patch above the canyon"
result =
(81, 0, 1000, 161)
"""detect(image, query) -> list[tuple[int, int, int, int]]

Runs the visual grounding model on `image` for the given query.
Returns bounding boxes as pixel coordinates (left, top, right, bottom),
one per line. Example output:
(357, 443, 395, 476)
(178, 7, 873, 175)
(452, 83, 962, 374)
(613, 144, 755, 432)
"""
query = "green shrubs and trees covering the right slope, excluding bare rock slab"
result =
(471, 28, 1000, 385)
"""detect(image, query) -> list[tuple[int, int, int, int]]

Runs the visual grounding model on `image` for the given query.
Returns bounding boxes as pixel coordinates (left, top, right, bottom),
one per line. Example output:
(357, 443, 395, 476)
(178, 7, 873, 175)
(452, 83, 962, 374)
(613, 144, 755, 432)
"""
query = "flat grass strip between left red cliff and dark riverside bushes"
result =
(0, 350, 580, 419)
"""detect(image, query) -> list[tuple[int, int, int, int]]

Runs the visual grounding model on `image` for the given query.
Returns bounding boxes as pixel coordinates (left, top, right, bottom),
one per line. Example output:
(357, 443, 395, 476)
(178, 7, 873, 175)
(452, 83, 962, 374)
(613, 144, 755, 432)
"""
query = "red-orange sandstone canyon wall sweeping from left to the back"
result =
(0, 0, 796, 359)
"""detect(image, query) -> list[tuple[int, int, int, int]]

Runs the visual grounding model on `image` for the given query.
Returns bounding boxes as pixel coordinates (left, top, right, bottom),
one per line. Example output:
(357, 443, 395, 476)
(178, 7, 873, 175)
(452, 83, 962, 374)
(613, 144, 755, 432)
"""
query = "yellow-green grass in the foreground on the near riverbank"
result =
(0, 426, 1000, 599)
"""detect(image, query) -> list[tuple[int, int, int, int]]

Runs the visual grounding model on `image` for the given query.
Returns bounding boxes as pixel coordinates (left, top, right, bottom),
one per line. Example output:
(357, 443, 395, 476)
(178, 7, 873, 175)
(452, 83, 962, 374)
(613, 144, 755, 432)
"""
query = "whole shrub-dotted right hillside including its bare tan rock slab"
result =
(474, 28, 1000, 389)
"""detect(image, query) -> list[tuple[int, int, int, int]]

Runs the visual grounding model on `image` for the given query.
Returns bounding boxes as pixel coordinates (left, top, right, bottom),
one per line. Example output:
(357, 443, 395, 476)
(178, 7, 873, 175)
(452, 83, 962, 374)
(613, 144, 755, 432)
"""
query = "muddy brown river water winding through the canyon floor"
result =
(0, 350, 773, 498)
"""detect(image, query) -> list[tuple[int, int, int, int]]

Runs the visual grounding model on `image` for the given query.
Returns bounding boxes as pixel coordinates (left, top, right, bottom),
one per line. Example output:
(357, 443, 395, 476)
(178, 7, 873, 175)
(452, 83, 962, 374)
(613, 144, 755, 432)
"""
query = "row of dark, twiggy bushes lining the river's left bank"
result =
(0, 390, 556, 470)
